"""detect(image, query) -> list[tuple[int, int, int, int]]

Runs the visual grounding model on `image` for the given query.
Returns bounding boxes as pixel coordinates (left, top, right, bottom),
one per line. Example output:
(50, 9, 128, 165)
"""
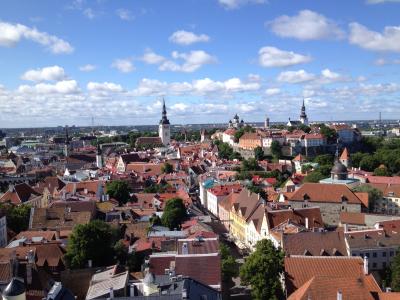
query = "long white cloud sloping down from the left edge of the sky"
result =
(0, 22, 74, 54)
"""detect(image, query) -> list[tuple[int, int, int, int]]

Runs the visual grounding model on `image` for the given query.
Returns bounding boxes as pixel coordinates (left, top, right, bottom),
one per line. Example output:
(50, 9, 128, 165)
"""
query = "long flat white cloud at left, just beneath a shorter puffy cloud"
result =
(18, 80, 80, 94)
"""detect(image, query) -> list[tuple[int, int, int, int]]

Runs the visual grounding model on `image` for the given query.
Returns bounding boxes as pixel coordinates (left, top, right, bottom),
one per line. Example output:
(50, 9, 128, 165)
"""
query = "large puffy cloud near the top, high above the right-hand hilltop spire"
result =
(267, 10, 344, 41)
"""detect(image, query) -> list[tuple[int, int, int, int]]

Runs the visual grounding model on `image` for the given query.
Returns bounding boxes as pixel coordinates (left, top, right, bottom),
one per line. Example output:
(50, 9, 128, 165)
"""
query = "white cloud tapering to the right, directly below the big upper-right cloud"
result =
(258, 46, 311, 67)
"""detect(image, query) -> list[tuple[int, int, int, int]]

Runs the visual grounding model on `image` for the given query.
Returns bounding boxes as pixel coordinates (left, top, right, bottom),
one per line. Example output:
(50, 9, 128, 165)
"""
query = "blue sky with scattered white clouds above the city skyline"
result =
(0, 0, 400, 128)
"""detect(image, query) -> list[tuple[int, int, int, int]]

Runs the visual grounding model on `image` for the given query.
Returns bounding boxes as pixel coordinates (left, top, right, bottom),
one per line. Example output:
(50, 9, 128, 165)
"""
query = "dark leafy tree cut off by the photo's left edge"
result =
(0, 203, 31, 234)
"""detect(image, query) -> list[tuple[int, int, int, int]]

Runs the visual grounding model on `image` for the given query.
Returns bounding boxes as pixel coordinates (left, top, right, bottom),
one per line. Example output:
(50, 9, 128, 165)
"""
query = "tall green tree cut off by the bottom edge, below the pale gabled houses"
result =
(240, 239, 284, 300)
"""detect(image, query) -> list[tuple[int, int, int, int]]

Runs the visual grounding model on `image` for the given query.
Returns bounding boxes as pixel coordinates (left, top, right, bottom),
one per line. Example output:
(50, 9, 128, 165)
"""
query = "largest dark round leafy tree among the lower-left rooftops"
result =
(65, 220, 117, 269)
